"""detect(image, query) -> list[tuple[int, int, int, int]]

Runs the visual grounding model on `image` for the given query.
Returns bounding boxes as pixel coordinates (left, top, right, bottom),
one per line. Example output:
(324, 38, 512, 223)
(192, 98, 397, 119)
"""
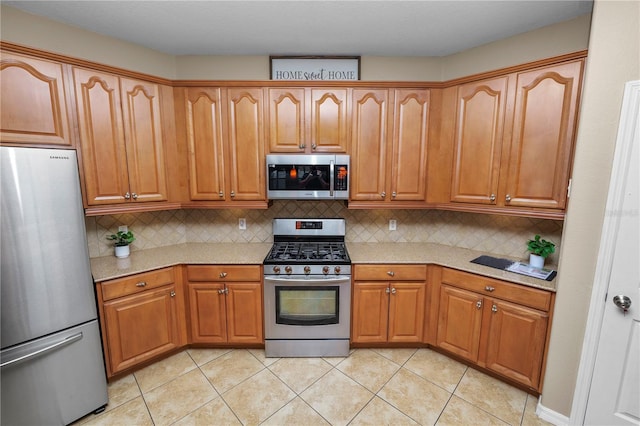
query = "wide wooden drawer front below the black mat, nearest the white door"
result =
(442, 268, 551, 311)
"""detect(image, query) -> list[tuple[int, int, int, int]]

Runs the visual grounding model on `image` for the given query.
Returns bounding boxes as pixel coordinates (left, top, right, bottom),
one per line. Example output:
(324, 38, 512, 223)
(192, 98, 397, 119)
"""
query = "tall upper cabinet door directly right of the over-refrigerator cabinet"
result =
(73, 68, 129, 206)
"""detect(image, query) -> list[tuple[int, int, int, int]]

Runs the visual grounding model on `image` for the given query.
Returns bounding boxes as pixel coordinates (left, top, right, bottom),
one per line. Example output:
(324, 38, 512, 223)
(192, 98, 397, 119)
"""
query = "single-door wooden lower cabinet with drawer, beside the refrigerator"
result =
(97, 268, 187, 377)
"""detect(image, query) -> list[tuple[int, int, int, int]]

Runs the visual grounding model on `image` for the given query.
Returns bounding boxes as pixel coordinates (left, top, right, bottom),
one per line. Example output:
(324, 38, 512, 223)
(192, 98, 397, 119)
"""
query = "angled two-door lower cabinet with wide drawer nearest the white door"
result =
(436, 268, 553, 392)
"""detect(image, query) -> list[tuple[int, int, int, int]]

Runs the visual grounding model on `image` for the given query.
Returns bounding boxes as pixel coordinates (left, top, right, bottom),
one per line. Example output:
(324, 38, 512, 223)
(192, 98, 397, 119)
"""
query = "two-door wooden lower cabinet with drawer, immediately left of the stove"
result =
(187, 265, 264, 344)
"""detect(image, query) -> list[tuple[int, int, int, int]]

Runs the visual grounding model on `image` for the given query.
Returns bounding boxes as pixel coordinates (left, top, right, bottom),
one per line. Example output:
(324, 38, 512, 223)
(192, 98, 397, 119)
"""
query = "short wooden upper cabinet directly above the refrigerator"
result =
(0, 52, 73, 147)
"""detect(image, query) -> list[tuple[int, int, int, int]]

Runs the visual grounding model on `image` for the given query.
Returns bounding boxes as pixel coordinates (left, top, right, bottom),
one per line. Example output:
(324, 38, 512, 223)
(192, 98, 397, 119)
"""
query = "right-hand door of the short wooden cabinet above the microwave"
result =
(310, 89, 349, 152)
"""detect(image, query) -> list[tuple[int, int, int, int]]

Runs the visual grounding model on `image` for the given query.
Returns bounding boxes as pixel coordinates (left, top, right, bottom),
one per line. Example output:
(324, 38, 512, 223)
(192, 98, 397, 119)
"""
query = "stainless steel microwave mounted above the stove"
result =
(267, 154, 349, 200)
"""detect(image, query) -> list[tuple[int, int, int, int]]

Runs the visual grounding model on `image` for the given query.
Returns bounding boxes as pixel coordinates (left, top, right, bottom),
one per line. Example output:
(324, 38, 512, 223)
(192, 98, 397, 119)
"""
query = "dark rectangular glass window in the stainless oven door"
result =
(276, 286, 340, 325)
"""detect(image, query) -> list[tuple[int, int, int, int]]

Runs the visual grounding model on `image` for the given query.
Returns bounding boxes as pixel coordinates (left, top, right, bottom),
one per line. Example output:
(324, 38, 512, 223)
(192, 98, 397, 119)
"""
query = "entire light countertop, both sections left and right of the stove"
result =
(91, 243, 557, 291)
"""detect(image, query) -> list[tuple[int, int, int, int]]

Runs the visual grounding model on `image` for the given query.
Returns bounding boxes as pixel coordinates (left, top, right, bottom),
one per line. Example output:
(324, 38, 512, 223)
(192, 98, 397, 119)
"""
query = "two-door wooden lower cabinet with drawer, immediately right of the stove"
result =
(351, 265, 426, 343)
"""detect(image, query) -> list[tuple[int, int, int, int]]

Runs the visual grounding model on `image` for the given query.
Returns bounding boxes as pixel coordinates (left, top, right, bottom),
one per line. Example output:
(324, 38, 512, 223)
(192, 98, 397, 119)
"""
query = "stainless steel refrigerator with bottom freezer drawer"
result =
(0, 146, 107, 425)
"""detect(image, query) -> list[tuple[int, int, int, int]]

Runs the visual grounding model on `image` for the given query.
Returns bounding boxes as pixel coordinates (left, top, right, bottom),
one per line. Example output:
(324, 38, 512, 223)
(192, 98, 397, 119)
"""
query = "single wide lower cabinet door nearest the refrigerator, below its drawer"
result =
(104, 286, 180, 374)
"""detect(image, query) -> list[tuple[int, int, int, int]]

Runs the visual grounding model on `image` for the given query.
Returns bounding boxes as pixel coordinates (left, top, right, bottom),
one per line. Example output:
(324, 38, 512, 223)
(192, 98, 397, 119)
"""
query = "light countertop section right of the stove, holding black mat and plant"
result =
(347, 243, 557, 292)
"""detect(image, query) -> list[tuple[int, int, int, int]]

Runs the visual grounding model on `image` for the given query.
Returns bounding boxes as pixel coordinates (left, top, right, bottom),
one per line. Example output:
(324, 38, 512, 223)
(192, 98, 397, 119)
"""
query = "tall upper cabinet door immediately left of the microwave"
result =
(227, 88, 266, 201)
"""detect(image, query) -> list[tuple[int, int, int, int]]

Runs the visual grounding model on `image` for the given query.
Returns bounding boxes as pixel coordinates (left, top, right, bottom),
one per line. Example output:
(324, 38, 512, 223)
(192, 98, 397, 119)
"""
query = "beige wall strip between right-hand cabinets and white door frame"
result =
(541, 0, 640, 416)
